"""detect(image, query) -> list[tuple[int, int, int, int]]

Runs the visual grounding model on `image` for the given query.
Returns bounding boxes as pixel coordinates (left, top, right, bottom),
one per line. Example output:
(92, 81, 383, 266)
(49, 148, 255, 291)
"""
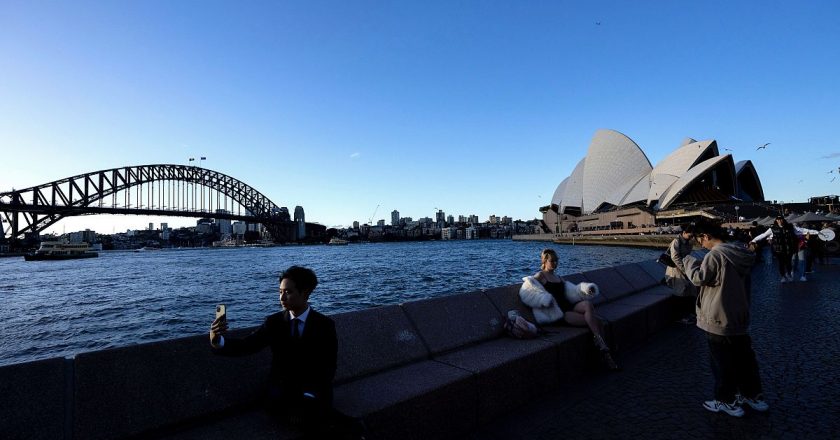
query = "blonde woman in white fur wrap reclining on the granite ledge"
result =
(519, 249, 619, 371)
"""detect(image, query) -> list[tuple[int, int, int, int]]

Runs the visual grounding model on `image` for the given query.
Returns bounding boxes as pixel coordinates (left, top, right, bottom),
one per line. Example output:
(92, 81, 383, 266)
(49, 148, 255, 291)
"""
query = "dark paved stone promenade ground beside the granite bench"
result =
(468, 254, 840, 440)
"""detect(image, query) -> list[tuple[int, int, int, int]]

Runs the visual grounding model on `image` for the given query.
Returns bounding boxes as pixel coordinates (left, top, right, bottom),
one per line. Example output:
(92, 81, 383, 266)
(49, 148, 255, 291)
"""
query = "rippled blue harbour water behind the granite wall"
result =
(0, 240, 660, 365)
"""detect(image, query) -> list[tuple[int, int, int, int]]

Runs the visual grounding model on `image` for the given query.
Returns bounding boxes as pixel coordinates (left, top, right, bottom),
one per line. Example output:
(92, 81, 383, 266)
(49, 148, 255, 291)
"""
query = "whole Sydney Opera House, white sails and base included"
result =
(540, 130, 764, 232)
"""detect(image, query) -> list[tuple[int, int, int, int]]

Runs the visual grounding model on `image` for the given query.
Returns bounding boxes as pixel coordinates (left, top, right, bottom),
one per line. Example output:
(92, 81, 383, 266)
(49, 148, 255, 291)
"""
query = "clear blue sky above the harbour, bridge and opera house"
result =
(0, 0, 840, 233)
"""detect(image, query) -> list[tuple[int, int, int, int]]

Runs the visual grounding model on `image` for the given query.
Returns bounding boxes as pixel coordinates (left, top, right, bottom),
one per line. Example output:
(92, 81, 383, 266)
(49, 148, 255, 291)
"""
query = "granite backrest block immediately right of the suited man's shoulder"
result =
(331, 305, 429, 383)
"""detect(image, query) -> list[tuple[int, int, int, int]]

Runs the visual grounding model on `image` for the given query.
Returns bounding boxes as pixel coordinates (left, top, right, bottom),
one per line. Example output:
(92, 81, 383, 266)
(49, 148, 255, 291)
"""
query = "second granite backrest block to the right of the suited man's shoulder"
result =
(402, 292, 504, 356)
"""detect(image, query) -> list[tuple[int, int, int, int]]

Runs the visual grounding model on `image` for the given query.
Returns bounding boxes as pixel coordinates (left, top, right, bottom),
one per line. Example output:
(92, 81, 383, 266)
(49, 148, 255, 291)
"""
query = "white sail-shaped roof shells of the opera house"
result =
(551, 129, 764, 214)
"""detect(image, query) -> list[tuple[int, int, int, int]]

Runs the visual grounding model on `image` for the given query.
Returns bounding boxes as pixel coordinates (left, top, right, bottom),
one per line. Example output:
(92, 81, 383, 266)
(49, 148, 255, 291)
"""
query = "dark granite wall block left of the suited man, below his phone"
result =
(74, 329, 271, 439)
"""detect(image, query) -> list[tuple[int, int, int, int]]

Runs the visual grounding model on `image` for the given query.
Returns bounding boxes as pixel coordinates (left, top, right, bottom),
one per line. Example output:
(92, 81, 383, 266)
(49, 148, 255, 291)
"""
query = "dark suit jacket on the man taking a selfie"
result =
(213, 309, 338, 402)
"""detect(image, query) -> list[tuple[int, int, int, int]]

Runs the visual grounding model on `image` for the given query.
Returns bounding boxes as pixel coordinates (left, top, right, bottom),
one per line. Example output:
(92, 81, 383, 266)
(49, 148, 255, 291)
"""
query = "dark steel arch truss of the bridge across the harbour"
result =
(0, 164, 291, 242)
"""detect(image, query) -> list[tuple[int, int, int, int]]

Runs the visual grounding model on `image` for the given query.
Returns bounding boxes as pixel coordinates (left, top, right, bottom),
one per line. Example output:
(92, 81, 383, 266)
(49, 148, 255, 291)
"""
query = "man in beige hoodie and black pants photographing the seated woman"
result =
(685, 225, 769, 417)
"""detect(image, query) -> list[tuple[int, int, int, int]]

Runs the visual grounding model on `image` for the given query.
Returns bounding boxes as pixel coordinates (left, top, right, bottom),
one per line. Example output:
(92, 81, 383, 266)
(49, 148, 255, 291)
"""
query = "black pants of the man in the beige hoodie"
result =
(706, 332, 761, 403)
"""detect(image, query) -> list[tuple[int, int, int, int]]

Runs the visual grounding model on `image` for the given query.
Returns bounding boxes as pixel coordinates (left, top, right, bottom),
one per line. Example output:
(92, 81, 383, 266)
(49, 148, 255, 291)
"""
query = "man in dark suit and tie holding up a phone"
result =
(210, 266, 338, 432)
